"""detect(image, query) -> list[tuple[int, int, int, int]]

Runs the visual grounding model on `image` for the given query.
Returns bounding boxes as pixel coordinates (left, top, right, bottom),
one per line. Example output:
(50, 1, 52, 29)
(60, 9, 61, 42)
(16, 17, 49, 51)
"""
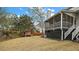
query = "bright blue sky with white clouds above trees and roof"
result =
(6, 7, 64, 15)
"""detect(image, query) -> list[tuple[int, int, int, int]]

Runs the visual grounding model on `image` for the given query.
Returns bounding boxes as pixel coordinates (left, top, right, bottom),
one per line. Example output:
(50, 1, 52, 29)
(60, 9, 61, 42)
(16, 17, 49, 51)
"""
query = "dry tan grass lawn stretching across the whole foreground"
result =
(0, 36, 79, 51)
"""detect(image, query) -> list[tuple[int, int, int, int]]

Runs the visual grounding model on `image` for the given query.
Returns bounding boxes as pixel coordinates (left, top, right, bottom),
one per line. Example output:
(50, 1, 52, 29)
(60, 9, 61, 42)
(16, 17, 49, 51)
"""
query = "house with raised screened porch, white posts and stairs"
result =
(44, 7, 79, 40)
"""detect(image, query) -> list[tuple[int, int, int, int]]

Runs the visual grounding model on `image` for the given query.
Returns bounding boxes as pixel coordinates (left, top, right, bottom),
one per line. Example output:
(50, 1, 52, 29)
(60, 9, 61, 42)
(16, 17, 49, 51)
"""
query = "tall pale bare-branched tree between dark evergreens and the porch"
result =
(30, 7, 45, 34)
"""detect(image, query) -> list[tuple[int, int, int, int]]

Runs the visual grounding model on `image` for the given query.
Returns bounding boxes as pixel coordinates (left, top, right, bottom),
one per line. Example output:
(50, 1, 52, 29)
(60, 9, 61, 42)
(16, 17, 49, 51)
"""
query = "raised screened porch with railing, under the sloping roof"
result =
(45, 13, 74, 30)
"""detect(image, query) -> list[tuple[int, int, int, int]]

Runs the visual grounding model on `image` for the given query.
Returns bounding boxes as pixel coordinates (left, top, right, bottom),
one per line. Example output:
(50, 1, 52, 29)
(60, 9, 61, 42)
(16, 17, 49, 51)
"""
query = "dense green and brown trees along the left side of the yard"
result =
(0, 7, 34, 37)
